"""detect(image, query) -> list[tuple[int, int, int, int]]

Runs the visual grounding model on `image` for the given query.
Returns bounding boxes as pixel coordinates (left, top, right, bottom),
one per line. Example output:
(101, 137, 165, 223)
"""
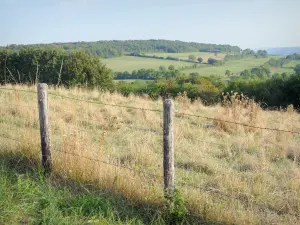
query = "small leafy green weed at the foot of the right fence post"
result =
(165, 189, 188, 225)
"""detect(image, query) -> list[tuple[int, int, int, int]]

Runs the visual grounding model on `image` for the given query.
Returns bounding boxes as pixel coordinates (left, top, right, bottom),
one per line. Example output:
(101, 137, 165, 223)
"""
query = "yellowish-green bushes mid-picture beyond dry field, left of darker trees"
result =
(116, 70, 221, 103)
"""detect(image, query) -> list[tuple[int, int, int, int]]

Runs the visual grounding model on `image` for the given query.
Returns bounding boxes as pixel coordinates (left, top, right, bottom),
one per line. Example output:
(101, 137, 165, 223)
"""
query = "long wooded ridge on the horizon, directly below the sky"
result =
(0, 40, 241, 58)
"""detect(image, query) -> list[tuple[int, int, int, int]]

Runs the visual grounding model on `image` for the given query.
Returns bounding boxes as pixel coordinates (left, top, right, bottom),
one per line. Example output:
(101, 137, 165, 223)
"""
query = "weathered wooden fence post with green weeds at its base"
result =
(163, 98, 175, 191)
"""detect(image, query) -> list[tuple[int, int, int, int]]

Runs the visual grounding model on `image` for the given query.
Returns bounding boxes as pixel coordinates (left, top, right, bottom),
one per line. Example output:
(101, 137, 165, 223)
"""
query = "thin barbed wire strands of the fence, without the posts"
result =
(0, 85, 300, 220)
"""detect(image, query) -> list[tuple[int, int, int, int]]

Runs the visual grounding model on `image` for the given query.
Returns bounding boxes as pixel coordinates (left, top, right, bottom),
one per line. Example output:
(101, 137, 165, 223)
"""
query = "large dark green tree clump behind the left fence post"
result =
(0, 48, 113, 89)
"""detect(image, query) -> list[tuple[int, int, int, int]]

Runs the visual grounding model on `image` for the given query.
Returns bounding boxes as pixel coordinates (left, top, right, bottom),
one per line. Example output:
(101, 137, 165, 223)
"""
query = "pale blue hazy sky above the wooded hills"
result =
(0, 0, 300, 49)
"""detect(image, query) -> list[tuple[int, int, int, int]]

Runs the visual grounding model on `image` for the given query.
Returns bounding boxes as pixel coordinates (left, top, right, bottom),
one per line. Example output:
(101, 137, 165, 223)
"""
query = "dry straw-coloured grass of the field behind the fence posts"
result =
(0, 86, 300, 224)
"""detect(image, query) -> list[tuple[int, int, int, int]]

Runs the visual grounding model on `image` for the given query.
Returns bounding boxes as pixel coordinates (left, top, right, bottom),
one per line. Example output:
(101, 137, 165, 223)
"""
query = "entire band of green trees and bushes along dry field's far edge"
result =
(0, 48, 300, 107)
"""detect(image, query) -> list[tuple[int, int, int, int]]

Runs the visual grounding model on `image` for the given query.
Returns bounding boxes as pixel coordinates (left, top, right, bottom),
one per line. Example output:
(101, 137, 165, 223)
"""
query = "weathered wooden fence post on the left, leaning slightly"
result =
(37, 83, 52, 173)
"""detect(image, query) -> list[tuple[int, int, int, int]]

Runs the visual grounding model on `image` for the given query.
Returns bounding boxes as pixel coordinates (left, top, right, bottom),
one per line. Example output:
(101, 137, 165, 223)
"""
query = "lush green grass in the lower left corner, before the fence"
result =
(0, 152, 168, 225)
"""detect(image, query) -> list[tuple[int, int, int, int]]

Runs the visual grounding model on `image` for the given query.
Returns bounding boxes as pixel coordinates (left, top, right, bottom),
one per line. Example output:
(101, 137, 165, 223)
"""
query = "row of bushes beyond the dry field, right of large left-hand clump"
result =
(116, 59, 300, 108)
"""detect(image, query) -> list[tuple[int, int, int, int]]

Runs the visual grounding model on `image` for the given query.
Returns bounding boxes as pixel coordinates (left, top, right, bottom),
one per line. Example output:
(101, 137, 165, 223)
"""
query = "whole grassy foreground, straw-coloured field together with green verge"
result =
(0, 86, 300, 224)
